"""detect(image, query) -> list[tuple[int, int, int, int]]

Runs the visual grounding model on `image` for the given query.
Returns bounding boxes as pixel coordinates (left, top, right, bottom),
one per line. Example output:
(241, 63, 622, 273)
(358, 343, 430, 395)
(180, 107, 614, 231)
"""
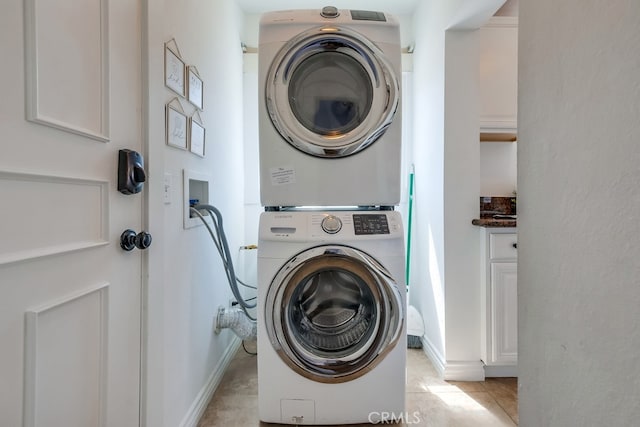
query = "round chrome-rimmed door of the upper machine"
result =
(265, 27, 400, 158)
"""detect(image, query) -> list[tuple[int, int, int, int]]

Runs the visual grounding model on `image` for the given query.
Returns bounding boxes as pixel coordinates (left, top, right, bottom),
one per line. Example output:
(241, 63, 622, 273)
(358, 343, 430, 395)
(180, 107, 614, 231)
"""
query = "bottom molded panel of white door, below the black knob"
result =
(23, 283, 109, 427)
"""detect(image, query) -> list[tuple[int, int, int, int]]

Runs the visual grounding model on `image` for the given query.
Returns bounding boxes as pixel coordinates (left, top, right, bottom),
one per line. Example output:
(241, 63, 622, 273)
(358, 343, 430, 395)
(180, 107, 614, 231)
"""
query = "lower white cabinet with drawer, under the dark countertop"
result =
(481, 228, 518, 376)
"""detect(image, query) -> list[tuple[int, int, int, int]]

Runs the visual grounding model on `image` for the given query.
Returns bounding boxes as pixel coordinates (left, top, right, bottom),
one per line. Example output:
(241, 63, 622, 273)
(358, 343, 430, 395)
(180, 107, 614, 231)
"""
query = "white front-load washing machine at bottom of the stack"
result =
(258, 211, 407, 425)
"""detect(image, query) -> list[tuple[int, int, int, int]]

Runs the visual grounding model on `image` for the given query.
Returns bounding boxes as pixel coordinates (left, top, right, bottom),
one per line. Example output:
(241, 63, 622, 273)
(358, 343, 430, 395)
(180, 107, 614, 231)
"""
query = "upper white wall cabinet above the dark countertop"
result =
(478, 16, 518, 133)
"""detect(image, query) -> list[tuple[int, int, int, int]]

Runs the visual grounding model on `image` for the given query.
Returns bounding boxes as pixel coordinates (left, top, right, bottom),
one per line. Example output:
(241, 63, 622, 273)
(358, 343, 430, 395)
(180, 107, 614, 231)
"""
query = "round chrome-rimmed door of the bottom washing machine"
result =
(264, 245, 404, 383)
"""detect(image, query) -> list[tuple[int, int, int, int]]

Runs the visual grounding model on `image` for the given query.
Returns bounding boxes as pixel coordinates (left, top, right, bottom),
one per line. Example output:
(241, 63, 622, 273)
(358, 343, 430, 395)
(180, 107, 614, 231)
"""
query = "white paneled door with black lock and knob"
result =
(0, 0, 144, 427)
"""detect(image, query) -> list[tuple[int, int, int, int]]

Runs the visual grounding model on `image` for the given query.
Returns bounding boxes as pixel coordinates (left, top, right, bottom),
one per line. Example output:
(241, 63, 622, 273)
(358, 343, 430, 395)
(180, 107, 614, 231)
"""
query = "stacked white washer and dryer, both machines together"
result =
(258, 7, 406, 425)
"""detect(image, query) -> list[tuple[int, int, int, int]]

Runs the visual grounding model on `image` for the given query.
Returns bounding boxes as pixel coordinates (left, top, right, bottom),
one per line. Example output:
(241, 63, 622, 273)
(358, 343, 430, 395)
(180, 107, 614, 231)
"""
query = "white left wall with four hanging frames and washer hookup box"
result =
(143, 0, 245, 427)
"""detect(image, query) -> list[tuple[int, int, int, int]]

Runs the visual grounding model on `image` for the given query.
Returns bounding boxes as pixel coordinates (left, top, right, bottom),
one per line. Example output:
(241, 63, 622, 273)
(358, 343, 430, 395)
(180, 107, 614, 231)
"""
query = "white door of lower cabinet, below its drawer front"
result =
(491, 262, 518, 364)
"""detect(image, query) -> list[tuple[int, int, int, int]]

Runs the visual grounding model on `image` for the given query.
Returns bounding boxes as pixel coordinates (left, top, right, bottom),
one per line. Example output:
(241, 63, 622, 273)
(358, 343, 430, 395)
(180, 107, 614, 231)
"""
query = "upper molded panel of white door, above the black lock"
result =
(24, 0, 110, 142)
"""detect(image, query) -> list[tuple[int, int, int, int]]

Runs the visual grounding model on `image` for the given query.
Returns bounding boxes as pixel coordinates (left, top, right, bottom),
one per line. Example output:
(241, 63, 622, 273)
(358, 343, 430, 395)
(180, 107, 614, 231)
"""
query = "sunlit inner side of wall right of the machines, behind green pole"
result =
(409, 2, 445, 368)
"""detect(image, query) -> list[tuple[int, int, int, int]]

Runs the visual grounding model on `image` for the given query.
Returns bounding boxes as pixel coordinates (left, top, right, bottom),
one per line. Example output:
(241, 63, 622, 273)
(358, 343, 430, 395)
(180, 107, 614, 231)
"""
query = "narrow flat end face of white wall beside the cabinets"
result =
(444, 29, 488, 372)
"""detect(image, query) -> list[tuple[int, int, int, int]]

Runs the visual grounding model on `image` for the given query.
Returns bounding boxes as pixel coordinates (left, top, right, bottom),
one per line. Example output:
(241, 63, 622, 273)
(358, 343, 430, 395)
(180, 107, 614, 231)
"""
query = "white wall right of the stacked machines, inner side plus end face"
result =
(410, 0, 504, 380)
